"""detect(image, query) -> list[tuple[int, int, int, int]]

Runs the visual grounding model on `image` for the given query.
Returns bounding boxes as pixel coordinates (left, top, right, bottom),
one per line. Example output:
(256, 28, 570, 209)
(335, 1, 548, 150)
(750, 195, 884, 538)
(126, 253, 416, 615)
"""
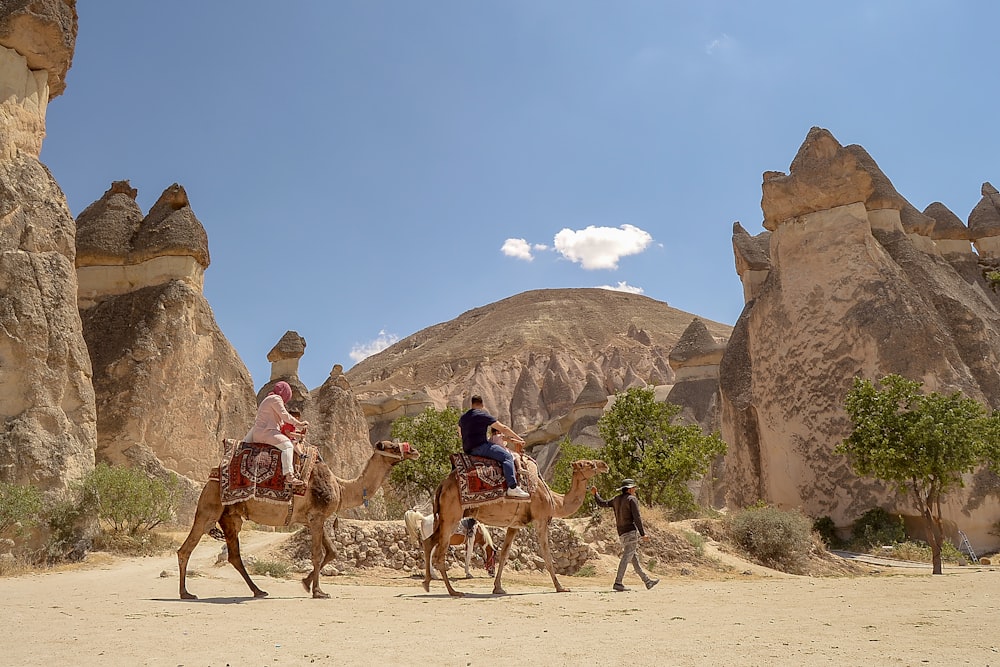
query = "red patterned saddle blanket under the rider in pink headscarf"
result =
(208, 438, 319, 505)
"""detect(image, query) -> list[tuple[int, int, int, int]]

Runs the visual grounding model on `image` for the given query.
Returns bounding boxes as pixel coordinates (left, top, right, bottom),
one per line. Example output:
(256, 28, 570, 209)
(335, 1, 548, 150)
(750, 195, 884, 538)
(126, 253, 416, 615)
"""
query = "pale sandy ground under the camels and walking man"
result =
(0, 533, 1000, 667)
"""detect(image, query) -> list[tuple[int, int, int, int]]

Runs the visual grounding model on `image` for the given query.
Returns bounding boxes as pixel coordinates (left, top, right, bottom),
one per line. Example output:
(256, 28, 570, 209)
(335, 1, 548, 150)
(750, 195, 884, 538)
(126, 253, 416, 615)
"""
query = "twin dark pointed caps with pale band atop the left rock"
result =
(76, 181, 210, 308)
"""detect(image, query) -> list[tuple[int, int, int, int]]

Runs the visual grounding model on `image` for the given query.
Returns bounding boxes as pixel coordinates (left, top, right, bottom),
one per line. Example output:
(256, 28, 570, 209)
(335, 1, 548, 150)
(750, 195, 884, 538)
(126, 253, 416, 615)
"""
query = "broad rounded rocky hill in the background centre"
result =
(346, 288, 731, 452)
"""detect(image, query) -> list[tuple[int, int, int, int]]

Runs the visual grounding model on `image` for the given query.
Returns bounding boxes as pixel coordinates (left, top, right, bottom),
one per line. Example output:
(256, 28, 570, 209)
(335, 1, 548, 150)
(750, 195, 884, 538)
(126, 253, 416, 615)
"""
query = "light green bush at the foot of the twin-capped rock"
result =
(82, 463, 180, 535)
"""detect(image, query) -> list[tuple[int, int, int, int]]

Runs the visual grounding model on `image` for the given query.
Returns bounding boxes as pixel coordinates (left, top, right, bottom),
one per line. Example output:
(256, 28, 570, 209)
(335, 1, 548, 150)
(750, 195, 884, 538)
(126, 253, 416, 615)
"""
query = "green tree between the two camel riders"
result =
(389, 407, 462, 496)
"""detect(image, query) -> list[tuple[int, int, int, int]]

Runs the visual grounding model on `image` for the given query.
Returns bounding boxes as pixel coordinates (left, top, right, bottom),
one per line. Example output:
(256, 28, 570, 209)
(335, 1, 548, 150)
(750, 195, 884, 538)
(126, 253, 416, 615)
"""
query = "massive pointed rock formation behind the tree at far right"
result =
(724, 128, 1000, 546)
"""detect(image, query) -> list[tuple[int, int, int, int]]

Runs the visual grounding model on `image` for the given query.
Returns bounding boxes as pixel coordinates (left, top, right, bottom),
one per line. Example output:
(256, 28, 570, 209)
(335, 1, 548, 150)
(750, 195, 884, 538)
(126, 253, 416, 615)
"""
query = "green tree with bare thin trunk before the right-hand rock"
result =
(835, 375, 990, 574)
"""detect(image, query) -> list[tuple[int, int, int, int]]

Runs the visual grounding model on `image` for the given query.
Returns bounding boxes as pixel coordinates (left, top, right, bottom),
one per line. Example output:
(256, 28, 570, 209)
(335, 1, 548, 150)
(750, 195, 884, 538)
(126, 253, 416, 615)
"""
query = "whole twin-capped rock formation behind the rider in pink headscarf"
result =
(76, 181, 256, 481)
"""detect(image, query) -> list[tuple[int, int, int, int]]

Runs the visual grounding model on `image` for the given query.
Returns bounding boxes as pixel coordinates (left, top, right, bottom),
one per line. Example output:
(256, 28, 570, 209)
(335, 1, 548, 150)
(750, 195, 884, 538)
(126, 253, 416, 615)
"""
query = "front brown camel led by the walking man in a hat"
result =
(424, 461, 608, 597)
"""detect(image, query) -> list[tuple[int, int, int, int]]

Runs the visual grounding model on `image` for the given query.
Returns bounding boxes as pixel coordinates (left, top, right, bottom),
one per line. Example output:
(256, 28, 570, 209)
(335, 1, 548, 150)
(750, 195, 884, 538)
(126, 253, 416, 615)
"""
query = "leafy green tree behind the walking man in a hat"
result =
(597, 388, 726, 513)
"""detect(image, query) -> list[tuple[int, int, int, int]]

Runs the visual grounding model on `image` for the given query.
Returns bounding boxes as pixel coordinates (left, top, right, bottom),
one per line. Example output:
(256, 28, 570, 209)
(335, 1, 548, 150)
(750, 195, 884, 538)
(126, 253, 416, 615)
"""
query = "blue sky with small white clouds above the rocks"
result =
(42, 0, 1000, 388)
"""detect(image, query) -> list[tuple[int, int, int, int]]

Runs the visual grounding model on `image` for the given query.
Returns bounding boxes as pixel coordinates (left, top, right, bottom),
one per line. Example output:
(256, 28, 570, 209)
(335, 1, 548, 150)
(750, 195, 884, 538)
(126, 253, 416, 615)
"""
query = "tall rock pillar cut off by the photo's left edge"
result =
(0, 0, 97, 490)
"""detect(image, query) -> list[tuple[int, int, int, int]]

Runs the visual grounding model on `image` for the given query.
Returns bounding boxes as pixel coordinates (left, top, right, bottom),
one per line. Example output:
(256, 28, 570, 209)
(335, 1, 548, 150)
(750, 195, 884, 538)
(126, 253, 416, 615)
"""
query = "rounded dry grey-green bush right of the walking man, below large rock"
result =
(725, 507, 813, 569)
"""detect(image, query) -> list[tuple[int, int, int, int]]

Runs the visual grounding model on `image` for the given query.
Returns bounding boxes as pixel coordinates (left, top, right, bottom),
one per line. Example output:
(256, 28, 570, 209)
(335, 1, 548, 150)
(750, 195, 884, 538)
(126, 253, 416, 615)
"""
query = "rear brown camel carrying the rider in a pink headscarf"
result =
(177, 440, 420, 600)
